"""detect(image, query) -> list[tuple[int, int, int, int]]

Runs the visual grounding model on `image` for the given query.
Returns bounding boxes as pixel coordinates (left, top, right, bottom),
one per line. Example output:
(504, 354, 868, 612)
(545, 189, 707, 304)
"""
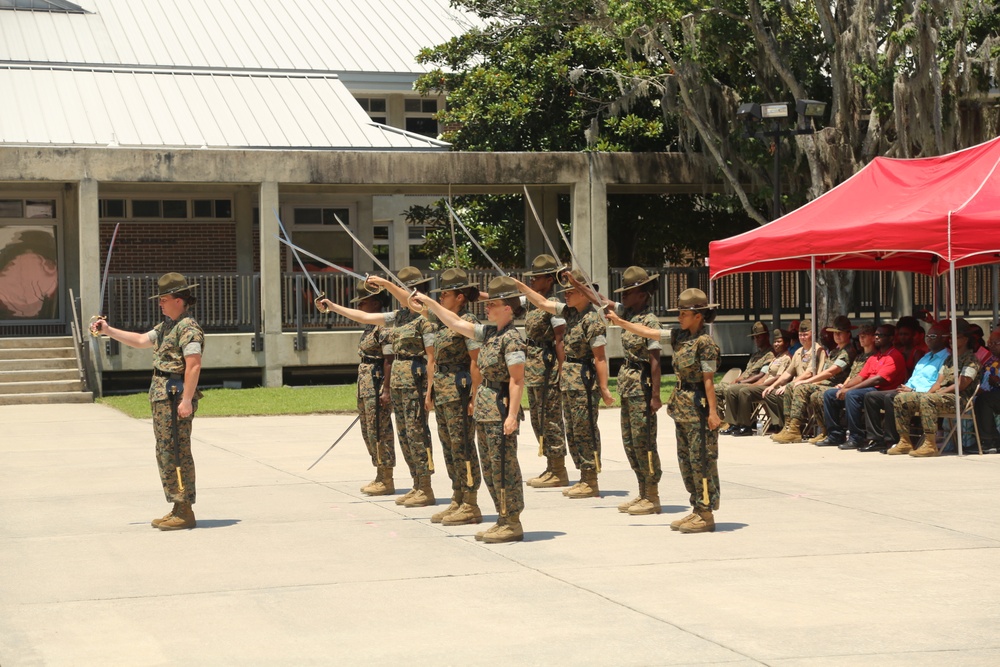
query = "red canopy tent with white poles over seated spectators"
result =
(708, 138, 1000, 454)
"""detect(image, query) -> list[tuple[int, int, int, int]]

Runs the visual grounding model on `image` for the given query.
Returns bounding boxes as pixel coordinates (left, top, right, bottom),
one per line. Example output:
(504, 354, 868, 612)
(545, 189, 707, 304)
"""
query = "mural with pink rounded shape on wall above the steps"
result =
(0, 225, 59, 320)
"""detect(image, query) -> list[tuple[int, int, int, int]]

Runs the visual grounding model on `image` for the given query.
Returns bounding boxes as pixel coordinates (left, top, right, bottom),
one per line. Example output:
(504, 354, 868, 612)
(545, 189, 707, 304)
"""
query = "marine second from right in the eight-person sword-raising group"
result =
(608, 266, 663, 516)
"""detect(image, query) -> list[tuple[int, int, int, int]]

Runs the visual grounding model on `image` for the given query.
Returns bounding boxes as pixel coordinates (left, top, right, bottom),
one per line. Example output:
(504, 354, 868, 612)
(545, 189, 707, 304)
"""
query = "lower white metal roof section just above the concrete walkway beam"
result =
(0, 65, 447, 150)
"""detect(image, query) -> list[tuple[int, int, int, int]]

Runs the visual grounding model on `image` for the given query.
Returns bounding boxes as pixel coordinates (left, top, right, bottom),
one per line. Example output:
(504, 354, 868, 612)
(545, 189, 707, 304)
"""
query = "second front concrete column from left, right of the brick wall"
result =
(260, 181, 282, 387)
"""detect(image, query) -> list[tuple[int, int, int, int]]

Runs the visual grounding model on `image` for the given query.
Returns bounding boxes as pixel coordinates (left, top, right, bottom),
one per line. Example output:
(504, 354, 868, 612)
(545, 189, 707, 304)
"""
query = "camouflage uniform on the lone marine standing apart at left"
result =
(148, 315, 205, 504)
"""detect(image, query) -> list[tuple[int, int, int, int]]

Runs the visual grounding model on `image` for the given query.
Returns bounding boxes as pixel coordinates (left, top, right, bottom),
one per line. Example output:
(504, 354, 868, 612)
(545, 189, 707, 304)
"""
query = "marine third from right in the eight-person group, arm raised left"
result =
(515, 269, 614, 499)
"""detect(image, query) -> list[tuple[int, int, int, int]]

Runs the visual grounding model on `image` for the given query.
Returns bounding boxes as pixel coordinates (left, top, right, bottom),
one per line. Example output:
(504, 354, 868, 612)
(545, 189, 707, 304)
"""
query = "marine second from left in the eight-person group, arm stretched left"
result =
(332, 266, 436, 507)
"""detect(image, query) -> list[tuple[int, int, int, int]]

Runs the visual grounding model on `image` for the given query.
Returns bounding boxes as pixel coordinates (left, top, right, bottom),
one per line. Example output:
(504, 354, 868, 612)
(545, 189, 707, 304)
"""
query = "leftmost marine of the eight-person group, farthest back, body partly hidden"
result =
(330, 280, 396, 496)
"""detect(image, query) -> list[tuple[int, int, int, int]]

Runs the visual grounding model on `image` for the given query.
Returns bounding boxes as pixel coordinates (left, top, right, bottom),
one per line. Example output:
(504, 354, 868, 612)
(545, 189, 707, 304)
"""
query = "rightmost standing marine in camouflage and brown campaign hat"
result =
(667, 288, 721, 533)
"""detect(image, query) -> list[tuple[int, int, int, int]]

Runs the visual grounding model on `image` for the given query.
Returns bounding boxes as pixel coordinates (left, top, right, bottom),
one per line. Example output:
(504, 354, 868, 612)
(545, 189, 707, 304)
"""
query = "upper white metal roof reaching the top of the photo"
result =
(0, 0, 478, 83)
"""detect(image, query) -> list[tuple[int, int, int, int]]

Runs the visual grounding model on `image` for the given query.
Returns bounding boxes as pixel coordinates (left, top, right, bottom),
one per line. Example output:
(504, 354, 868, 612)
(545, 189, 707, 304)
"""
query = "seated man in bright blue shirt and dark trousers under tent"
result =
(859, 324, 950, 452)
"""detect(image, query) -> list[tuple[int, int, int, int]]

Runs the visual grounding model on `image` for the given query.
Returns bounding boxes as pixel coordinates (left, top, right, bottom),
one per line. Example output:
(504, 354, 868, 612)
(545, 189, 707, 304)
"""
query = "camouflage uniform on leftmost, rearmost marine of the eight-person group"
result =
(358, 325, 396, 468)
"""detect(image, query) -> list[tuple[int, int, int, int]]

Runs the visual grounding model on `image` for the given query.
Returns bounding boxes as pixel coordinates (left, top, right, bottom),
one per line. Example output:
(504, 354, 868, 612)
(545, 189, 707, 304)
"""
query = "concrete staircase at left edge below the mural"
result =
(0, 336, 94, 405)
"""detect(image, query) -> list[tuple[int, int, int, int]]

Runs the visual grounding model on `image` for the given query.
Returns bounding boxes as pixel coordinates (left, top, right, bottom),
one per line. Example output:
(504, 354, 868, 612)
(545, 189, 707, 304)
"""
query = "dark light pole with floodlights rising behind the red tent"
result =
(736, 100, 826, 330)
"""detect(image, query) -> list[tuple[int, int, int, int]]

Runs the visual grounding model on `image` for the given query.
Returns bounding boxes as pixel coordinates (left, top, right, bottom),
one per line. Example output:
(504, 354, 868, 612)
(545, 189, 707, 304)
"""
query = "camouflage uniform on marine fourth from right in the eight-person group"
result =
(524, 295, 566, 458)
